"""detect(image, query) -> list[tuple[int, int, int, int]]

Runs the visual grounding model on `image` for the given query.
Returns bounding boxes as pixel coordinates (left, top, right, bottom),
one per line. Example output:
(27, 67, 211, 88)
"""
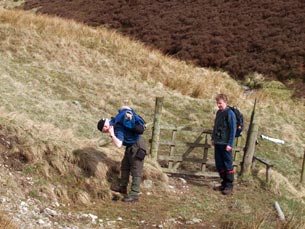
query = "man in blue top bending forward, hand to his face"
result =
(97, 106, 146, 202)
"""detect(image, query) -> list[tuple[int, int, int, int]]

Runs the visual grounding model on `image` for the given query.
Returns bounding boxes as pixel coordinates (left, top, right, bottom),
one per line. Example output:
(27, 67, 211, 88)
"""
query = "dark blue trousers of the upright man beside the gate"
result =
(215, 144, 234, 188)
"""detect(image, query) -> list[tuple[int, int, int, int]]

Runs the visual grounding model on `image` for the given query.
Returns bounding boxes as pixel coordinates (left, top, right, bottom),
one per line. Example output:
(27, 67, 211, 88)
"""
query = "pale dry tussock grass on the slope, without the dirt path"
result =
(0, 9, 305, 226)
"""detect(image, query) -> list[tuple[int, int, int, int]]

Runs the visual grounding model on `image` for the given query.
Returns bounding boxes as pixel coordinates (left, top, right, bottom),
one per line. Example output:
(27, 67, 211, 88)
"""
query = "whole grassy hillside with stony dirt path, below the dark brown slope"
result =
(0, 6, 305, 228)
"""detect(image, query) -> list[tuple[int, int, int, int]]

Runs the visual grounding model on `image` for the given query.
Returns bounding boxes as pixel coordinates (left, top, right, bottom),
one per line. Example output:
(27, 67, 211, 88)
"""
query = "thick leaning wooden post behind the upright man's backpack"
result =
(241, 123, 258, 175)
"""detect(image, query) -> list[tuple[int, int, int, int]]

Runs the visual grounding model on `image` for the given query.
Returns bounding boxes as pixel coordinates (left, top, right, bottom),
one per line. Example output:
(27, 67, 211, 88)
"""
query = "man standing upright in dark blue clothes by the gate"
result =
(212, 94, 236, 195)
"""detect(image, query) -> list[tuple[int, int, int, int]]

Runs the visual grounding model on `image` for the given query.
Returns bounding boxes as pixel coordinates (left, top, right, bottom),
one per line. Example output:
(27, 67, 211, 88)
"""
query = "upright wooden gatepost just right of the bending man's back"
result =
(150, 97, 163, 160)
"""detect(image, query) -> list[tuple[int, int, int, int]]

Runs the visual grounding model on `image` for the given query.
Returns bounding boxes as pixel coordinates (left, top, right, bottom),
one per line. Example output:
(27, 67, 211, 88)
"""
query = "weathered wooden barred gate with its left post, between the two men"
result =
(150, 97, 243, 177)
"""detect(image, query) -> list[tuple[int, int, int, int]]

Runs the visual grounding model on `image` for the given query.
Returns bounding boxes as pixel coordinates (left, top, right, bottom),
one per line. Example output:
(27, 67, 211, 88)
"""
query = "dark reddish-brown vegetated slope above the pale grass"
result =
(24, 0, 305, 95)
